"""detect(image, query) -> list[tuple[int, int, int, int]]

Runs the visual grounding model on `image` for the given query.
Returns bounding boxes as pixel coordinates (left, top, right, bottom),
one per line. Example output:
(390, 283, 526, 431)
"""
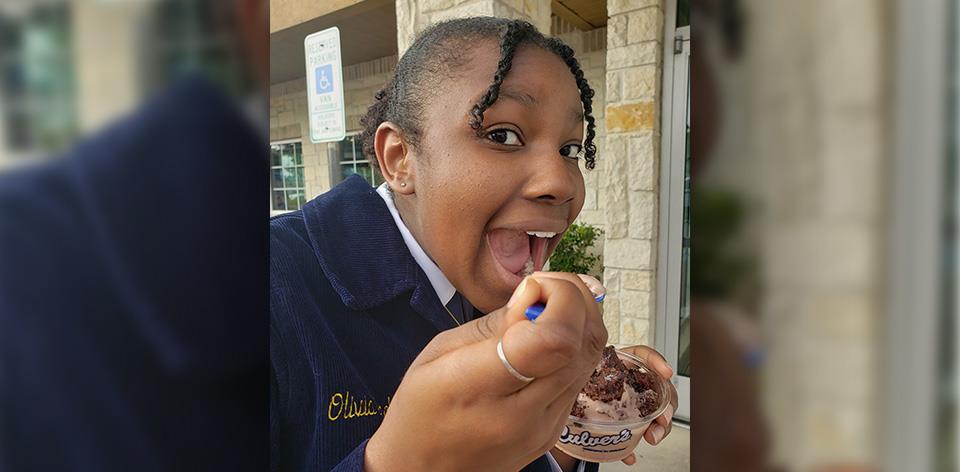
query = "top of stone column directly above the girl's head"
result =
(397, 0, 550, 56)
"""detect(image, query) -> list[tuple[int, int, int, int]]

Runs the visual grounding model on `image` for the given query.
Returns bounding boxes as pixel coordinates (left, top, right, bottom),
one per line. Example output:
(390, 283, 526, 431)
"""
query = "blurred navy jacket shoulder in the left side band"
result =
(0, 77, 269, 472)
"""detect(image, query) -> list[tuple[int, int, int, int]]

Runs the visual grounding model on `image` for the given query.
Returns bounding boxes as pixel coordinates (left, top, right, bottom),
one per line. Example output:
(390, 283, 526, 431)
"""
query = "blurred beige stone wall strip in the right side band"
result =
(747, 0, 884, 470)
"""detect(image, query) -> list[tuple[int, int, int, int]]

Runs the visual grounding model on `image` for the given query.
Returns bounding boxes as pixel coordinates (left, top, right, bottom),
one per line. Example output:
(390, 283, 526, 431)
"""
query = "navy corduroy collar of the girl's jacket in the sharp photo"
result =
(303, 175, 452, 329)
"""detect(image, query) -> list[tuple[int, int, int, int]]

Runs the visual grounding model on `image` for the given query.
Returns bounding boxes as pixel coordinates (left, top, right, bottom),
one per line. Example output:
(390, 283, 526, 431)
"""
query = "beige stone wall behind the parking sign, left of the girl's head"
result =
(270, 56, 397, 212)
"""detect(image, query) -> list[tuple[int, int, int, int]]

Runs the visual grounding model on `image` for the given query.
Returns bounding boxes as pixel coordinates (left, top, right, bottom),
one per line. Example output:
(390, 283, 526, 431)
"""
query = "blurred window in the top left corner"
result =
(0, 3, 77, 154)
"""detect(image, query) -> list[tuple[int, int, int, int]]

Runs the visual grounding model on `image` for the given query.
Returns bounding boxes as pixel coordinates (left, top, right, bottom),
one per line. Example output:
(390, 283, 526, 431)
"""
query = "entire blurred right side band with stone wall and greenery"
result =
(690, 0, 960, 471)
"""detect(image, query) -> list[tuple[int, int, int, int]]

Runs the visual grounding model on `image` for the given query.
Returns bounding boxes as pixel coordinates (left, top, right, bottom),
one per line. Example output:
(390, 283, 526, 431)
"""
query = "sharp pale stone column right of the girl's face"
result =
(597, 0, 664, 345)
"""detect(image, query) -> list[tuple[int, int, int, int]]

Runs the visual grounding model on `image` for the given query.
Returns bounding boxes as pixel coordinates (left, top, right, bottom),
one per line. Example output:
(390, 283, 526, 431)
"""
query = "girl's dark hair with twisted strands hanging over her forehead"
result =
(360, 17, 597, 169)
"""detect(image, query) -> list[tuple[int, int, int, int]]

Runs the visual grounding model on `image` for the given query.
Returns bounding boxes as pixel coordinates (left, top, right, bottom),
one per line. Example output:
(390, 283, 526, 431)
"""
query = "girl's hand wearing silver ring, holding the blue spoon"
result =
(364, 272, 607, 472)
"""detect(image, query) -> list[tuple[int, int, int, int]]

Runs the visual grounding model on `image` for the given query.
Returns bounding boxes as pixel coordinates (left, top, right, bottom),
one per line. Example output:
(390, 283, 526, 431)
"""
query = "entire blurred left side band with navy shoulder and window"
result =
(0, 0, 269, 471)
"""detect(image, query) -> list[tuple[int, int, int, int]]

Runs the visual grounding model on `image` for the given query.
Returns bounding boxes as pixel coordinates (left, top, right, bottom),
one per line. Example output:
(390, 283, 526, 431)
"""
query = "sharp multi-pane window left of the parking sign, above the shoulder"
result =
(270, 142, 307, 211)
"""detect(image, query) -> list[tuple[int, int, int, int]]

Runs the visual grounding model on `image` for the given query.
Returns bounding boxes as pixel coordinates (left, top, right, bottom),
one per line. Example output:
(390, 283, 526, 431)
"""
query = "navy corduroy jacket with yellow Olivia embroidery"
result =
(270, 176, 596, 472)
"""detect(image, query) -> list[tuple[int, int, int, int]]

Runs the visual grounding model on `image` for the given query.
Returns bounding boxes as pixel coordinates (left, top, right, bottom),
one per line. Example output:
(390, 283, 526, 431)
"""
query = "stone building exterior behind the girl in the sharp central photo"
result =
(270, 0, 676, 382)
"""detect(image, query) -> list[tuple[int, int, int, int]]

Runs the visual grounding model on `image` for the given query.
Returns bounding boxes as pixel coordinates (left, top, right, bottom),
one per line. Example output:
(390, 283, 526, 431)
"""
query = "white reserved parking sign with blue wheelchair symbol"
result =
(303, 26, 346, 143)
